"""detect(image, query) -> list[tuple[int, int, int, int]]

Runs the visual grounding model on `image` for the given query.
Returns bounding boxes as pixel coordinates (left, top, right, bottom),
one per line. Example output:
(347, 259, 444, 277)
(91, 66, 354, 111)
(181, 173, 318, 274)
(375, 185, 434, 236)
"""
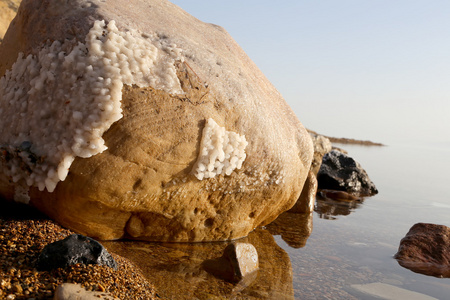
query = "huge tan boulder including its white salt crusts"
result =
(0, 0, 313, 241)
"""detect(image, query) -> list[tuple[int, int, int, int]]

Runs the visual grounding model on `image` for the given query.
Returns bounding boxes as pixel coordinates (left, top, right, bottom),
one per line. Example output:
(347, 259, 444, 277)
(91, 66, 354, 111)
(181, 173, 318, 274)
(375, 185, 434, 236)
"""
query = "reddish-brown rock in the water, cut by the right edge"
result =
(394, 223, 450, 278)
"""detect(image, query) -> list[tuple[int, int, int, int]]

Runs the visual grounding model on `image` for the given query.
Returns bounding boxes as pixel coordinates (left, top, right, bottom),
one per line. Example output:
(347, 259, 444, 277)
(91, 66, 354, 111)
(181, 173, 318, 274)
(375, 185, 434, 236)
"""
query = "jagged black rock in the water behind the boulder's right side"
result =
(317, 150, 378, 197)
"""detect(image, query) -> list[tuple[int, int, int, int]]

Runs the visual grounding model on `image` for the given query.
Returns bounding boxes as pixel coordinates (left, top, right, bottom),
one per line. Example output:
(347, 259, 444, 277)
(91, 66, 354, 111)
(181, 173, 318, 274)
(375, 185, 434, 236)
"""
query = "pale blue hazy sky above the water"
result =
(171, 0, 450, 147)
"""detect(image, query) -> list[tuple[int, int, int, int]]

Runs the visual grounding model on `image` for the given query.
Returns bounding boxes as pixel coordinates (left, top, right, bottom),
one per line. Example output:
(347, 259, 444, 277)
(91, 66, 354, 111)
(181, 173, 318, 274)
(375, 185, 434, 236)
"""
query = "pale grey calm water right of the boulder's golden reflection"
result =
(282, 145, 450, 299)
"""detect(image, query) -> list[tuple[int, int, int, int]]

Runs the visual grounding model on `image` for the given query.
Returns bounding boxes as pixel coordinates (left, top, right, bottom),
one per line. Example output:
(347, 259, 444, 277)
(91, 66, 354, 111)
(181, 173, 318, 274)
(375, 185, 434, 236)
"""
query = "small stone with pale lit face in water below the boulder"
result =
(203, 243, 259, 283)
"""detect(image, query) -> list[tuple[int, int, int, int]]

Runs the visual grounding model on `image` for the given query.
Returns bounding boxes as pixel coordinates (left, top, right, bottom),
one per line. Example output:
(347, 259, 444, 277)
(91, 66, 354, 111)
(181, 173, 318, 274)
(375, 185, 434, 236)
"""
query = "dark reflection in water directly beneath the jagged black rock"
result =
(314, 190, 364, 220)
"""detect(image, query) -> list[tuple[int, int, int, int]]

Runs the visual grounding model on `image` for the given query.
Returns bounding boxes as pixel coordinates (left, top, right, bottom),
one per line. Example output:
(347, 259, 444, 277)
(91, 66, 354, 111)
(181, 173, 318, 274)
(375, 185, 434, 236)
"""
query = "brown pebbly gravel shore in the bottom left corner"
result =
(0, 200, 159, 300)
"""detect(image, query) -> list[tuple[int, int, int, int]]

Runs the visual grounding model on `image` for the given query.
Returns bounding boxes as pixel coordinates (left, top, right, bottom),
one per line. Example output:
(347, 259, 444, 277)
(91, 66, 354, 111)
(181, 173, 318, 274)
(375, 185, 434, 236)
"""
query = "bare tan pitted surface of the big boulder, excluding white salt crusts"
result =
(0, 0, 313, 242)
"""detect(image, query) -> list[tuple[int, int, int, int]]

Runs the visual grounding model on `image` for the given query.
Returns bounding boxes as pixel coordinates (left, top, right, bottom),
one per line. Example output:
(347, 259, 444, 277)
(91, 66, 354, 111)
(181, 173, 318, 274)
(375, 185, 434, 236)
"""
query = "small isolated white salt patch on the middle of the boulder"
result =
(193, 118, 248, 180)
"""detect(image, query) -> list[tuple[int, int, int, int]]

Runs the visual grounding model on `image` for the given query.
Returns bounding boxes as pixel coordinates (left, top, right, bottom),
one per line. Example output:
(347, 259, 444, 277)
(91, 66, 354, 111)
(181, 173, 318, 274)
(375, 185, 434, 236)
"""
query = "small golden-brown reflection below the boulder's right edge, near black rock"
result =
(266, 212, 313, 248)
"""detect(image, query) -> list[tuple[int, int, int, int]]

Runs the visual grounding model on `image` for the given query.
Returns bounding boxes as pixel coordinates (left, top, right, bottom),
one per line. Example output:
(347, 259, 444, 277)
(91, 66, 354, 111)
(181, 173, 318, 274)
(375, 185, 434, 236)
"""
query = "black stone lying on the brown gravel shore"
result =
(37, 234, 117, 271)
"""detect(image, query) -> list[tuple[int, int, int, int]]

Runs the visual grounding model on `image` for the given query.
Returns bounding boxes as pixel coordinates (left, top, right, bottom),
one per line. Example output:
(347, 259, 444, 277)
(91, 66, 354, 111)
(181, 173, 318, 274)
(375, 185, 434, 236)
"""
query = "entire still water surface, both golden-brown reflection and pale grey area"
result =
(105, 145, 450, 300)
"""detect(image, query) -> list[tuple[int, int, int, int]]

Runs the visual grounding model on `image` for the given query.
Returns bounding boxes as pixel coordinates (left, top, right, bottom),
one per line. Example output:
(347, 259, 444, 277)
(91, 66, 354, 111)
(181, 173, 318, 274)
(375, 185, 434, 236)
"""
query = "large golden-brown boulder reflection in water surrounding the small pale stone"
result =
(102, 229, 294, 299)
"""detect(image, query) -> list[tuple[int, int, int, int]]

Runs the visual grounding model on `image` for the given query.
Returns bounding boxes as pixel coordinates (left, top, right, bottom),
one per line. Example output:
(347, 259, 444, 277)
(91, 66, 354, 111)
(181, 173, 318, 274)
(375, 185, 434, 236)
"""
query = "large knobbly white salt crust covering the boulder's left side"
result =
(0, 21, 183, 193)
